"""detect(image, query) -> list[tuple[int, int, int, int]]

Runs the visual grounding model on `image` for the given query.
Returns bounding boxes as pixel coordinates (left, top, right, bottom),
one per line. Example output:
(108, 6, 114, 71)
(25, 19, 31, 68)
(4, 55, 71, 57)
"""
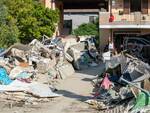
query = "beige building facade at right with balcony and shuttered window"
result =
(99, 0, 150, 49)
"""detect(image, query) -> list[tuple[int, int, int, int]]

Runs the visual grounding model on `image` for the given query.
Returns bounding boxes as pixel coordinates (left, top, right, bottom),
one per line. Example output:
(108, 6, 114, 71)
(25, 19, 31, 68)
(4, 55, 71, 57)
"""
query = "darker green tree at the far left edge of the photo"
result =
(0, 1, 19, 48)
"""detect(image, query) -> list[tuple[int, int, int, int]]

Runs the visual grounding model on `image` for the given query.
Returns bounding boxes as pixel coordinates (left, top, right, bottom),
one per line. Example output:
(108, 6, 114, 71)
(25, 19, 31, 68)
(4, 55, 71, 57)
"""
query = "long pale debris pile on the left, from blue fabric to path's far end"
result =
(0, 36, 99, 104)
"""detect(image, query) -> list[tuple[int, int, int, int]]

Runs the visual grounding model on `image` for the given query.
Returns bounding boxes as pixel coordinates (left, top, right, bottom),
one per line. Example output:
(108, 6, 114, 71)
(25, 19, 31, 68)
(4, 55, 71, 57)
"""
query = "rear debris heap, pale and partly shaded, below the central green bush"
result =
(67, 37, 100, 70)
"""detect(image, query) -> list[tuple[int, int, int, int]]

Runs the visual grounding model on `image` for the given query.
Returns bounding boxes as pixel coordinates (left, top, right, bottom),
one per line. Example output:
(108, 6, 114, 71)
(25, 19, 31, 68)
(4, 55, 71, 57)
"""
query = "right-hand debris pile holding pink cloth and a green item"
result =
(86, 53, 150, 113)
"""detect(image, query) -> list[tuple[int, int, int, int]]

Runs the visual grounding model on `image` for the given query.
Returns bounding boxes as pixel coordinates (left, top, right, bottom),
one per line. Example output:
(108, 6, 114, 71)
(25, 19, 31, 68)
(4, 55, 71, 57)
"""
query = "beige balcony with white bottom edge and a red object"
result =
(99, 12, 150, 28)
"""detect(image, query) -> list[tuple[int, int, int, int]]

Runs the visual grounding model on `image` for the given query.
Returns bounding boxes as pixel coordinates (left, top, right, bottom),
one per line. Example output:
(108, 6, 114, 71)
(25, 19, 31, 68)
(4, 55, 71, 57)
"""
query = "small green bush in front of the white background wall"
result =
(73, 21, 99, 36)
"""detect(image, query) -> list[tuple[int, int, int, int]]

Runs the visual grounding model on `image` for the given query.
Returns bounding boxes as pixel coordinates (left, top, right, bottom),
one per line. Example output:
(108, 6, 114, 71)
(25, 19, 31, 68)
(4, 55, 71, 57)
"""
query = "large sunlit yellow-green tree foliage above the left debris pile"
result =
(0, 0, 59, 46)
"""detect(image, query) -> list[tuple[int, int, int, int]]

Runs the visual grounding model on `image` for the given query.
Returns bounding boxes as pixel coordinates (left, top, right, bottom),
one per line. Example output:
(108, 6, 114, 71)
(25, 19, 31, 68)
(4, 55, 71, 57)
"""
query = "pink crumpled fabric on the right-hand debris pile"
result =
(101, 74, 112, 89)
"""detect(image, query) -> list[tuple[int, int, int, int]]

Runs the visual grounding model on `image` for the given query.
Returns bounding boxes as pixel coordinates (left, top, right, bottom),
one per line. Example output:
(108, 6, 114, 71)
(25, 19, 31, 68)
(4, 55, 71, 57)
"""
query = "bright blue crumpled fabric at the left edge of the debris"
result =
(0, 68, 12, 85)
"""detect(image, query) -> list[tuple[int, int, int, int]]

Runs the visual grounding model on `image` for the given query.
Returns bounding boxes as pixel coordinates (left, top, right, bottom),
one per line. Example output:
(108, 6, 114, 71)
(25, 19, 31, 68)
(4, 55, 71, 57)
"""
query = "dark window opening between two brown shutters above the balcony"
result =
(130, 0, 141, 12)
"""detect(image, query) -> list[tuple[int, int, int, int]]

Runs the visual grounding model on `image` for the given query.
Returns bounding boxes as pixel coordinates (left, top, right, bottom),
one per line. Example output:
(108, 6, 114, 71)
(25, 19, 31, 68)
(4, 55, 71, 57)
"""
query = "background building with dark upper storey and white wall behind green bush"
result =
(62, 0, 108, 35)
